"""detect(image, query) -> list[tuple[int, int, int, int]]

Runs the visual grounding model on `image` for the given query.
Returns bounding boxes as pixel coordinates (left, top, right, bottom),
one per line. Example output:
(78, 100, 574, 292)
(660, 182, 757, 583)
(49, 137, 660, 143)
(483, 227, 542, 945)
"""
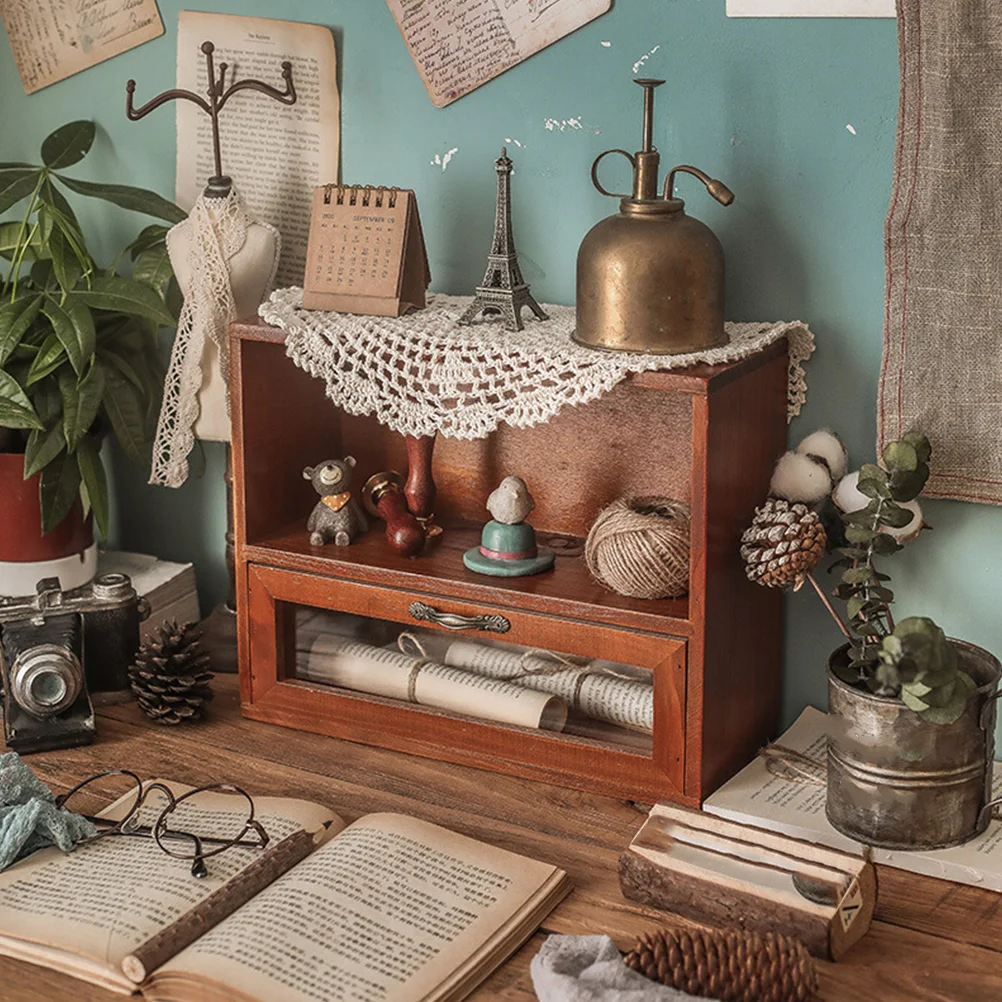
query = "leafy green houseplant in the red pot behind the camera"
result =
(0, 121, 184, 591)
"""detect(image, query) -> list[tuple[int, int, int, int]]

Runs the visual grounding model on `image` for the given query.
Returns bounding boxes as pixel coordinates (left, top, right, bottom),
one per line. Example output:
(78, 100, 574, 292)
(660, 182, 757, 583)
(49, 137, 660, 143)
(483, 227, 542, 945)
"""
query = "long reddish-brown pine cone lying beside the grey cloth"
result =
(624, 927, 818, 1002)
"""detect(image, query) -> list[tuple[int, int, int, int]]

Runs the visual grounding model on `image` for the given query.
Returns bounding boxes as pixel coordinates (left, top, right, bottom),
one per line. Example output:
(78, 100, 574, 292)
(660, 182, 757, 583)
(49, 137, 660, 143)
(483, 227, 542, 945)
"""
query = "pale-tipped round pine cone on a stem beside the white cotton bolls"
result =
(741, 498, 828, 589)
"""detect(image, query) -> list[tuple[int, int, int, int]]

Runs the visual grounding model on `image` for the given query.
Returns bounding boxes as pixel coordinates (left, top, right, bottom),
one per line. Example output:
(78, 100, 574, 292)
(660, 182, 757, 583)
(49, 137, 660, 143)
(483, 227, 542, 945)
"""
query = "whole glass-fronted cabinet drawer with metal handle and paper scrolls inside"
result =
(240, 563, 686, 800)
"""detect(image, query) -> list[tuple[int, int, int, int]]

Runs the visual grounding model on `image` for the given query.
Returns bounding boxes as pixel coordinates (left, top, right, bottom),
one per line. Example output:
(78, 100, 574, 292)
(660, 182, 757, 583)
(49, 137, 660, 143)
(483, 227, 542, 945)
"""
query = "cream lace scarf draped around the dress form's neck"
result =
(149, 187, 281, 487)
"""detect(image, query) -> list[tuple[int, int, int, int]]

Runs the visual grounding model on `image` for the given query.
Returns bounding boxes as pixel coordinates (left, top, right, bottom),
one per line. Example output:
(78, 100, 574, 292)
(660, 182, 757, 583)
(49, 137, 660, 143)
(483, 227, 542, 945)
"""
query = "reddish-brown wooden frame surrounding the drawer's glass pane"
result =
(240, 564, 696, 804)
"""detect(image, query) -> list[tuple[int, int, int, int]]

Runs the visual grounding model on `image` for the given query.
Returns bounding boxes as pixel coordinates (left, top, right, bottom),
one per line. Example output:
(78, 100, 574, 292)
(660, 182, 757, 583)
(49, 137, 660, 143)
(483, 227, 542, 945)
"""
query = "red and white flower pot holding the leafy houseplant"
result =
(0, 452, 96, 595)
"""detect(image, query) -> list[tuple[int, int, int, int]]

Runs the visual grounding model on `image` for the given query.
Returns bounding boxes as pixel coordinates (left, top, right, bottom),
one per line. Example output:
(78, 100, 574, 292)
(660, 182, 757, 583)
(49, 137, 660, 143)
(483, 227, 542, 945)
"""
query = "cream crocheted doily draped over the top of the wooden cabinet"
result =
(259, 288, 814, 439)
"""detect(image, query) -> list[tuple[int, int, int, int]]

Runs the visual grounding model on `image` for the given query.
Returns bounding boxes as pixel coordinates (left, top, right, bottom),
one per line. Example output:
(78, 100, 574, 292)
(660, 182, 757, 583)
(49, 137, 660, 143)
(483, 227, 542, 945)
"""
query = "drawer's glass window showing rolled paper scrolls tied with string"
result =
(290, 603, 654, 755)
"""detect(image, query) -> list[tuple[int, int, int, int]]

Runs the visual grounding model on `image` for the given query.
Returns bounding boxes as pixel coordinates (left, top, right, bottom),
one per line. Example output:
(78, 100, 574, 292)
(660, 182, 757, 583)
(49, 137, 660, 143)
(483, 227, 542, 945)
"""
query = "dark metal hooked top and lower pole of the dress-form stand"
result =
(125, 41, 297, 671)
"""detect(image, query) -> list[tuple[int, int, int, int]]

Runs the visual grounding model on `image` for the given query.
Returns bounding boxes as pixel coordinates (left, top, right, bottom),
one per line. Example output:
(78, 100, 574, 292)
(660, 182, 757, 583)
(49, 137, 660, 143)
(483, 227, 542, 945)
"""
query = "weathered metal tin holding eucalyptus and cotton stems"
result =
(826, 640, 1002, 850)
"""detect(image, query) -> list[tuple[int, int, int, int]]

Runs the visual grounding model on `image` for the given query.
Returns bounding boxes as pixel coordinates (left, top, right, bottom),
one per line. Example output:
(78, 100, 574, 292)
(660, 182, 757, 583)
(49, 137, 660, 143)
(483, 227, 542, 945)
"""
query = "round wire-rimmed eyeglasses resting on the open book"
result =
(56, 769, 269, 878)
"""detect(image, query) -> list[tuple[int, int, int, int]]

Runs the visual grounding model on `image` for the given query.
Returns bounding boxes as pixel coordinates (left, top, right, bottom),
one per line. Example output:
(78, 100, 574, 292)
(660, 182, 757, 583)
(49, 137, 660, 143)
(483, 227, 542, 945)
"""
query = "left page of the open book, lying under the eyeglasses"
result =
(0, 784, 343, 991)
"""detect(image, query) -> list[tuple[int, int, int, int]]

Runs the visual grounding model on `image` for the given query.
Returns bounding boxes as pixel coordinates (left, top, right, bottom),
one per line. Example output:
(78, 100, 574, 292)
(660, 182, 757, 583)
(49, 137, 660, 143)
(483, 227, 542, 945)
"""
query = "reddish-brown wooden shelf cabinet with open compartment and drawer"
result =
(230, 324, 788, 805)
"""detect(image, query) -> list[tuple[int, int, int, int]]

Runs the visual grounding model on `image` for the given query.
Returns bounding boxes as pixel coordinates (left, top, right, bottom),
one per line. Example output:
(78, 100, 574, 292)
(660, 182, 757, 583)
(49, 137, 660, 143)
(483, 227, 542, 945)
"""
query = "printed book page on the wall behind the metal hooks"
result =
(175, 11, 341, 288)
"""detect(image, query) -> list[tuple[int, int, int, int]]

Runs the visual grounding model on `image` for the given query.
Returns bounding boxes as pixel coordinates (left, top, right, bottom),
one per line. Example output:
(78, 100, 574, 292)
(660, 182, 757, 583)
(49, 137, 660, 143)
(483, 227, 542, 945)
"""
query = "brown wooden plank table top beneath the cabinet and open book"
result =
(0, 675, 1002, 1002)
